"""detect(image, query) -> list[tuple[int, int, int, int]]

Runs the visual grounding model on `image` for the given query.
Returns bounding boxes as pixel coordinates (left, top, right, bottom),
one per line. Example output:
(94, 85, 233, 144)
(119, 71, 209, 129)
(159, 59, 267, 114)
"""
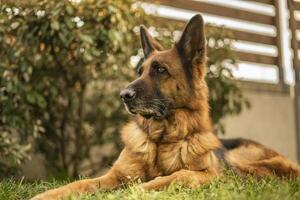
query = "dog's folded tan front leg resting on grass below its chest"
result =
(142, 170, 218, 190)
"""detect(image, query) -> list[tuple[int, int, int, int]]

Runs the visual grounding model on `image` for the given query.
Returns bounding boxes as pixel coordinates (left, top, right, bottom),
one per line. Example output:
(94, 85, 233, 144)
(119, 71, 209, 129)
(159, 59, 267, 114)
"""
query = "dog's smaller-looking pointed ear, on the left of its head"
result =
(140, 25, 163, 58)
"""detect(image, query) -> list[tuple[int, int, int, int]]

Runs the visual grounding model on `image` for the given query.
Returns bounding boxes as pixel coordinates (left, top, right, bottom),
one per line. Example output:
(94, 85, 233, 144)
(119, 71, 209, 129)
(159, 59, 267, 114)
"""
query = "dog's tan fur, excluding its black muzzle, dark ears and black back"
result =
(33, 14, 300, 200)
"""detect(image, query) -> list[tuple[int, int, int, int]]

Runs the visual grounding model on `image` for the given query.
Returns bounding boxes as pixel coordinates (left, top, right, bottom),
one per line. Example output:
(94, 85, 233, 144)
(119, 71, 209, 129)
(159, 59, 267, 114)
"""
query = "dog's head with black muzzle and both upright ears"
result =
(120, 15, 205, 120)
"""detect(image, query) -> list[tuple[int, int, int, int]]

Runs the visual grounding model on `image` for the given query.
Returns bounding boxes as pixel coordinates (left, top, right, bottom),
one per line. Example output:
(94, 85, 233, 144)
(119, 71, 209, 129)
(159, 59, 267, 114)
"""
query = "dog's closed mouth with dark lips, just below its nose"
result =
(125, 102, 169, 120)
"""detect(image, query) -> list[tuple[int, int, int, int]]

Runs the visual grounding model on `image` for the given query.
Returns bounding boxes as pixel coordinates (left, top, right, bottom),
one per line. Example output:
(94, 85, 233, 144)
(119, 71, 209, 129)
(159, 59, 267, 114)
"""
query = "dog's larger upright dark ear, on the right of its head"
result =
(175, 14, 206, 65)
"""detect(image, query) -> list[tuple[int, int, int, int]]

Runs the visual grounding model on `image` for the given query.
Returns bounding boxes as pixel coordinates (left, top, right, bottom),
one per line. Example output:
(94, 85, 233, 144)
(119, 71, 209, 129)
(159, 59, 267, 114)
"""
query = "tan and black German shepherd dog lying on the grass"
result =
(33, 15, 300, 200)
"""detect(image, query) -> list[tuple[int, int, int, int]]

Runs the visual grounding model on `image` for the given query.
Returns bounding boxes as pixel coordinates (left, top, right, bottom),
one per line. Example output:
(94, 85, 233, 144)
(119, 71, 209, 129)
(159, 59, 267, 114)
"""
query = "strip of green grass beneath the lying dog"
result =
(0, 175, 300, 200)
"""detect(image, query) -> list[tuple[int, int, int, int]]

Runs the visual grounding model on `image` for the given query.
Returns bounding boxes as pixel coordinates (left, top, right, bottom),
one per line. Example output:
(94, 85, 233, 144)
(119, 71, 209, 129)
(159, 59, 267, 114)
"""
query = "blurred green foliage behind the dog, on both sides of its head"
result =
(0, 0, 249, 177)
